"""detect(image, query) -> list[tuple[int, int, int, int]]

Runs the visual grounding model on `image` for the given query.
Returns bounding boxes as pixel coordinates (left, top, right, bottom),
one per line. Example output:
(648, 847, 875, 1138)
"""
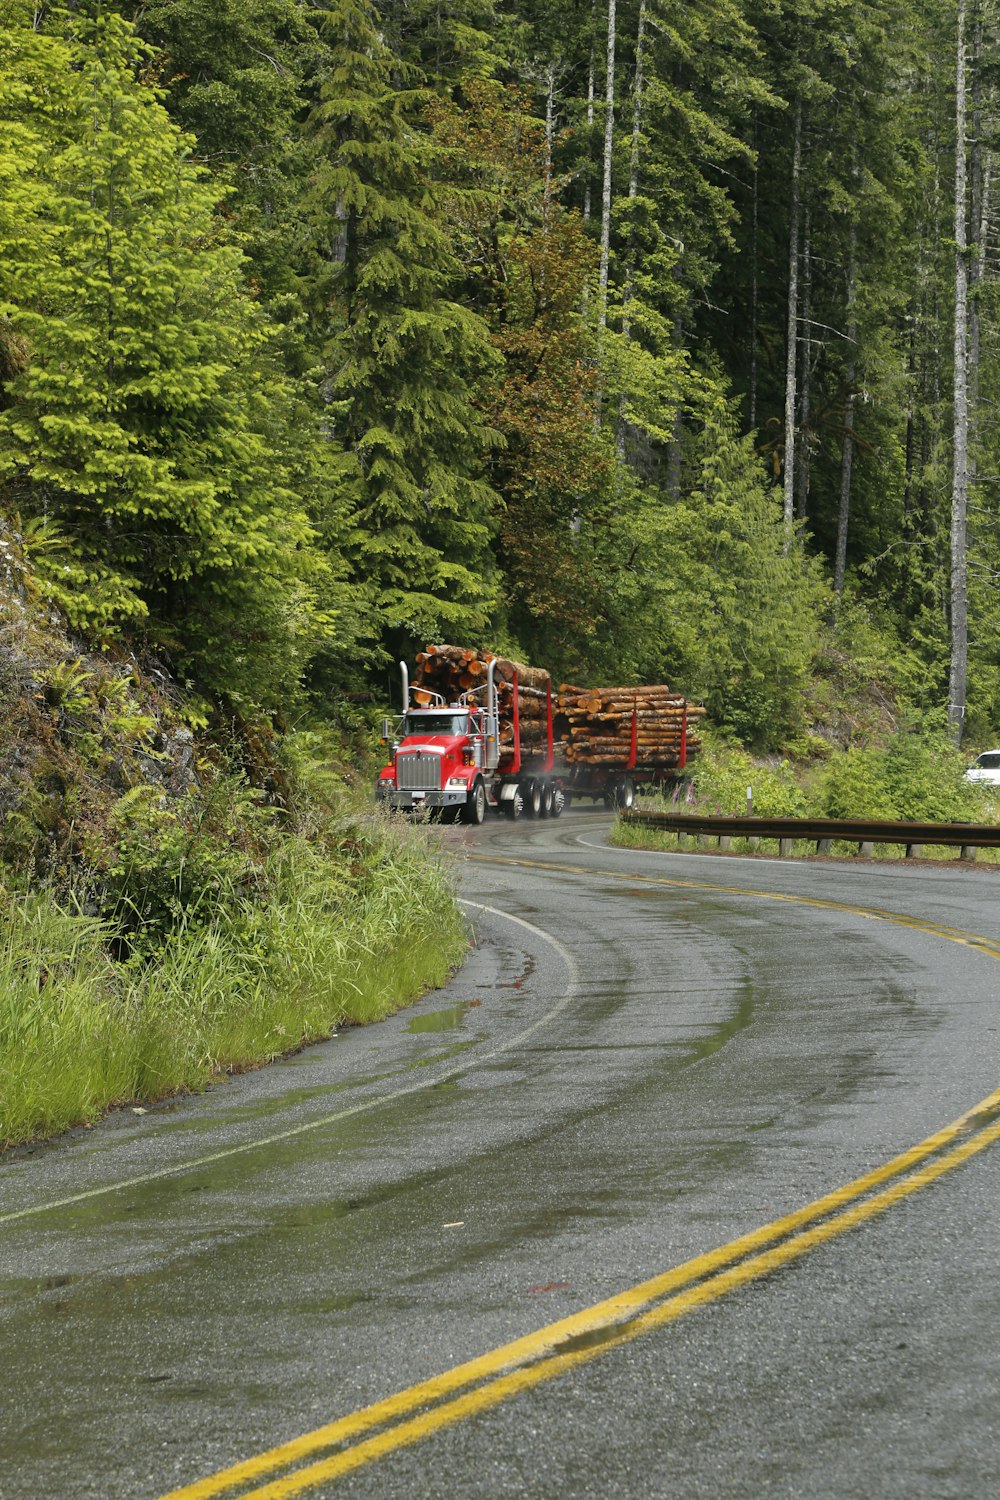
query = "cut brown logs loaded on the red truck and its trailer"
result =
(414, 645, 705, 770)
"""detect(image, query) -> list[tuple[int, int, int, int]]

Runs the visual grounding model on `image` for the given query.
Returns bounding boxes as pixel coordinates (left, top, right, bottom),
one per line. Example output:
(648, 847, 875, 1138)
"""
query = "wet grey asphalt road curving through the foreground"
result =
(0, 810, 1000, 1500)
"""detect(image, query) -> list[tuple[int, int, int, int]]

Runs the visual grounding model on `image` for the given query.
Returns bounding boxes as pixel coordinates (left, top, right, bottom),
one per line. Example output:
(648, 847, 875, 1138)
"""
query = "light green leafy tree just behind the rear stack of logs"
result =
(615, 393, 828, 750)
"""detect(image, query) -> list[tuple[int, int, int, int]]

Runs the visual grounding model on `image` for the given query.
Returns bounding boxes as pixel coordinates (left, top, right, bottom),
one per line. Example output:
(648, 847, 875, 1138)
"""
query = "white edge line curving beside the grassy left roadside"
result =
(0, 897, 579, 1224)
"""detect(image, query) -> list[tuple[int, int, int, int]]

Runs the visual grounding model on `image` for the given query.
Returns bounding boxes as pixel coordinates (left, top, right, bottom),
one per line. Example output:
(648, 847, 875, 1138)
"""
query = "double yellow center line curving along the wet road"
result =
(160, 857, 1000, 1500)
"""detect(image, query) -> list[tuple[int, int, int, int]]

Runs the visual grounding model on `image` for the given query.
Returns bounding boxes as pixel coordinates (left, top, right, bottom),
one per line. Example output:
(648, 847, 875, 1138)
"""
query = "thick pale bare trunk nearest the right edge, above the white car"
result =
(948, 0, 969, 744)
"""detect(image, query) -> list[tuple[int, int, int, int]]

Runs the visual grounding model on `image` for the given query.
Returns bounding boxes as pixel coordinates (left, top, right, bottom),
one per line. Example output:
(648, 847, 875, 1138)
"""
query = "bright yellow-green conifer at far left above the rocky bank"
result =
(0, 12, 315, 698)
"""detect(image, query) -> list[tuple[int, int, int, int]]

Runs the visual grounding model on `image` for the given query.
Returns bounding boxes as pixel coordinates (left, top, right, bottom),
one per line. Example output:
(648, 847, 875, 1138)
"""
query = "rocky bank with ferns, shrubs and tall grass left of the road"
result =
(0, 579, 466, 1146)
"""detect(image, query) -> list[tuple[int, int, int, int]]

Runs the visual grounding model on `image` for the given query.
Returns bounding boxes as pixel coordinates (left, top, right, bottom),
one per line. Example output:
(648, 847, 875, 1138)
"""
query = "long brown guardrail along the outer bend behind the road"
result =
(621, 809, 1000, 860)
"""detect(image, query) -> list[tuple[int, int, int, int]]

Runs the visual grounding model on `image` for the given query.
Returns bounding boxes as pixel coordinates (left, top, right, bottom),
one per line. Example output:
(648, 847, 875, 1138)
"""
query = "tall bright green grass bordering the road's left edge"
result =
(0, 824, 466, 1146)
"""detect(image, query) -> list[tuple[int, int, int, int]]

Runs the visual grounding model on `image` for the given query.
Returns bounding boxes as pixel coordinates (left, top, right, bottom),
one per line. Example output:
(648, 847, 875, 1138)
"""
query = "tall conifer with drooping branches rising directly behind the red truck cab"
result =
(312, 0, 496, 648)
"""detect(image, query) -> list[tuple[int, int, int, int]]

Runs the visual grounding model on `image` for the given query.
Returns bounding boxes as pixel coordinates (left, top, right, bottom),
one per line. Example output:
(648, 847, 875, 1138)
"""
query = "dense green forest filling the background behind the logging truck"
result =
(0, 0, 1000, 749)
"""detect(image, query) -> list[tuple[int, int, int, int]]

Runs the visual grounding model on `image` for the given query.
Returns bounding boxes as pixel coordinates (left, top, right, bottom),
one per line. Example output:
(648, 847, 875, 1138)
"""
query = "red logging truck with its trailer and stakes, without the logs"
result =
(375, 660, 688, 824)
